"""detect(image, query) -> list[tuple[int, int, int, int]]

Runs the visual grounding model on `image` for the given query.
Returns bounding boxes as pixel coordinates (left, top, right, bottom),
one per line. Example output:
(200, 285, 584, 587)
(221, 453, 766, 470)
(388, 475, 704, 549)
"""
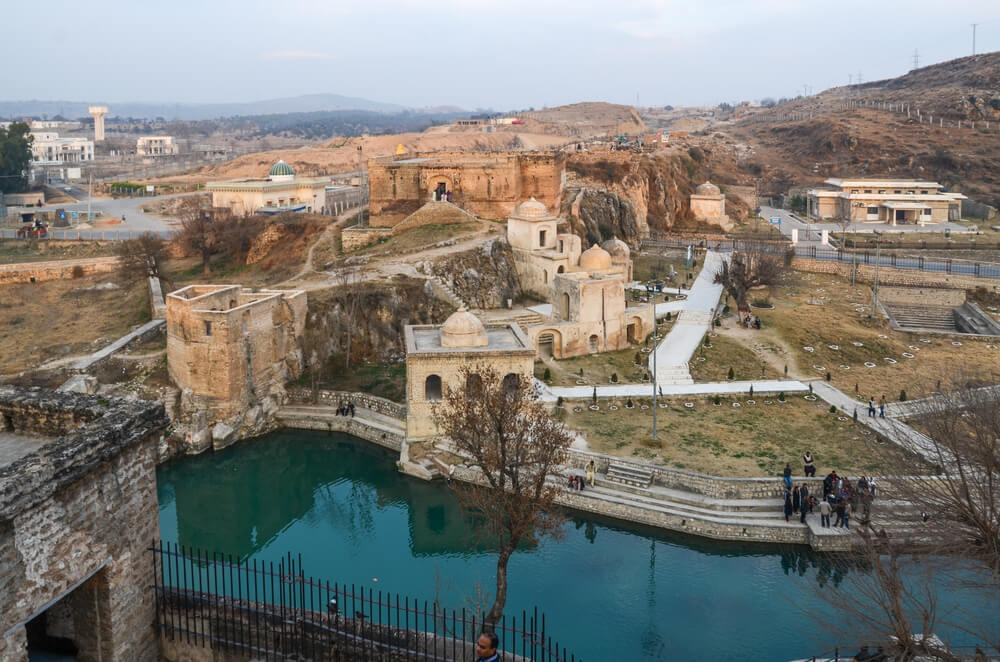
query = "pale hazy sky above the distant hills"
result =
(7, 0, 1000, 110)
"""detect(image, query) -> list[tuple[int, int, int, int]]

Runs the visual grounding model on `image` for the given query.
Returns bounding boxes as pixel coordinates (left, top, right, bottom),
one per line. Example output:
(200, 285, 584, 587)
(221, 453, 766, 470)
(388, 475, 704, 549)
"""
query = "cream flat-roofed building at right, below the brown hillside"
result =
(807, 179, 965, 225)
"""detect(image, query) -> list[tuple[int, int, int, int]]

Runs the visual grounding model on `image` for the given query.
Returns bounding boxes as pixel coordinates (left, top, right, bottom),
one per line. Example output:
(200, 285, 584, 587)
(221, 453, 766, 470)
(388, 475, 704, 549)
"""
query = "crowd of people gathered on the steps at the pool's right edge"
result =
(782, 451, 878, 529)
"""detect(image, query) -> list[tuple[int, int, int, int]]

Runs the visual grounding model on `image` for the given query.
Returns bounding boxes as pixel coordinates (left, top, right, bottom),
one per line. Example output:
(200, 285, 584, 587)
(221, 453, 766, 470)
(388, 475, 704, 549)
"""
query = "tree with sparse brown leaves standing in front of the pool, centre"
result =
(434, 365, 572, 627)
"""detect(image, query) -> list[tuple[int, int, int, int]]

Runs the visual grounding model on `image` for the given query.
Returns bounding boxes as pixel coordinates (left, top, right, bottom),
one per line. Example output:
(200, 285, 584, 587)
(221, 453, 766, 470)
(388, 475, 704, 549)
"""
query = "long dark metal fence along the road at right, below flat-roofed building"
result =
(643, 239, 1000, 279)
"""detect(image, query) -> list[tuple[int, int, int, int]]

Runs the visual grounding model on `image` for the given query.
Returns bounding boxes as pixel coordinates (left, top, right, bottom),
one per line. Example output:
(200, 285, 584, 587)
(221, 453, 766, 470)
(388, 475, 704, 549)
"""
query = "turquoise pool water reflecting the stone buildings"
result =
(157, 430, 1000, 662)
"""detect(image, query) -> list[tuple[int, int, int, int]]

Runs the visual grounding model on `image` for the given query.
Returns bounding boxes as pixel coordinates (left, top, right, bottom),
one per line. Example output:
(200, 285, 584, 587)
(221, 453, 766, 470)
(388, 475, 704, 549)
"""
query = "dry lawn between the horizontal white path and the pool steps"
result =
(564, 395, 929, 477)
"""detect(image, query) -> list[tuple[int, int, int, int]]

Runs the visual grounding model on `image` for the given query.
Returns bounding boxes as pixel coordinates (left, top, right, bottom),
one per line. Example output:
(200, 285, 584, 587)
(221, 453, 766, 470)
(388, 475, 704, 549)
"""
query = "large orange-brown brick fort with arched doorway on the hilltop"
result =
(368, 152, 566, 227)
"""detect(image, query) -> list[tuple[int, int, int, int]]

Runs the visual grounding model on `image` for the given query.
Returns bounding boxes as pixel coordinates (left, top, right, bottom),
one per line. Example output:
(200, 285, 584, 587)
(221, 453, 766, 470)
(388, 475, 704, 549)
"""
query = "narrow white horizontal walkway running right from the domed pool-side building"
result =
(535, 379, 809, 402)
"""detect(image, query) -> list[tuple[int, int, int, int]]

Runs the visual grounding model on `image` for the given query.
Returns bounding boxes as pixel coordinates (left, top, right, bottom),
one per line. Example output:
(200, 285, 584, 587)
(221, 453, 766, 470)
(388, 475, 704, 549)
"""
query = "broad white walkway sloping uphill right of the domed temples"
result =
(649, 251, 726, 388)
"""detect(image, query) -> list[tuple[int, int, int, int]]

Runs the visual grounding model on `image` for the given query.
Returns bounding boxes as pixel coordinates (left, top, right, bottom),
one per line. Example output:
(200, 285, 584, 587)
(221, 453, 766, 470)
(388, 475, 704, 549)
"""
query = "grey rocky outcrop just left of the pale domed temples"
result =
(430, 240, 521, 309)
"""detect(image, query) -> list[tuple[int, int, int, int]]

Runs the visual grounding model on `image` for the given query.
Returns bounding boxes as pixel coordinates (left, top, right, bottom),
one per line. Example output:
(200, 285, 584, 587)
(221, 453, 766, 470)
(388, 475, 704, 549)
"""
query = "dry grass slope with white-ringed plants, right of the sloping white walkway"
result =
(754, 272, 1000, 402)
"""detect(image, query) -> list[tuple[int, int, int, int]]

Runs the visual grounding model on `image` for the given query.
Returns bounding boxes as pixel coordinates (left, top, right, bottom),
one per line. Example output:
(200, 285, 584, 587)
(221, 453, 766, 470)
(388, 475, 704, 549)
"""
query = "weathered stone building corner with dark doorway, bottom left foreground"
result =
(0, 388, 169, 662)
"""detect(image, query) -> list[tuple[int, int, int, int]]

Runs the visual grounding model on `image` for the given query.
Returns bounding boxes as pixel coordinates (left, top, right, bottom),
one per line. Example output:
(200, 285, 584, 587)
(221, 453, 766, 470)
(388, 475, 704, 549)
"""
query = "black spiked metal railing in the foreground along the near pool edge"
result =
(149, 542, 579, 662)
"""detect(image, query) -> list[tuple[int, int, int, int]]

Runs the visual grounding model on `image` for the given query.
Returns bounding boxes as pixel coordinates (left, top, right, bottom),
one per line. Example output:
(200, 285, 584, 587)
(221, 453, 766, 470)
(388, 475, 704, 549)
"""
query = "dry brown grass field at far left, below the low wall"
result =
(0, 274, 150, 374)
